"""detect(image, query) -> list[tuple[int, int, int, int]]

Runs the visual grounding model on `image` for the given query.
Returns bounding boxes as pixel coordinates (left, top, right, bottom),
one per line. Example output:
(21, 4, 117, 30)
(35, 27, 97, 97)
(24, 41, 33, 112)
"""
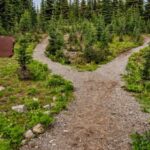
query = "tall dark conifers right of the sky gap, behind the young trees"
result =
(41, 0, 150, 23)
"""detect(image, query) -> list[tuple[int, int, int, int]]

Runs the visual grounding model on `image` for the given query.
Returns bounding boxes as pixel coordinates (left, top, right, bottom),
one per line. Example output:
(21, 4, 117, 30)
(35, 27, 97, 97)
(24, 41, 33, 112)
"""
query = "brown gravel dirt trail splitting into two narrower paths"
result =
(21, 38, 150, 150)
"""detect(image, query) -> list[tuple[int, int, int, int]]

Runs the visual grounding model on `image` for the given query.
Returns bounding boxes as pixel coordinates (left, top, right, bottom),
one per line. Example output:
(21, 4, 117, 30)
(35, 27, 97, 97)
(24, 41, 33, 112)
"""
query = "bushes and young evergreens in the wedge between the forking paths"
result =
(46, 10, 142, 71)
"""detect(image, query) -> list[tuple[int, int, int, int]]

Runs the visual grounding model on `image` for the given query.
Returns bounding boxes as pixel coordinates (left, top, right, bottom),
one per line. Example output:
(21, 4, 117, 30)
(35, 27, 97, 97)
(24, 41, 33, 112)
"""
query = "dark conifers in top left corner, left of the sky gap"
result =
(0, 0, 37, 33)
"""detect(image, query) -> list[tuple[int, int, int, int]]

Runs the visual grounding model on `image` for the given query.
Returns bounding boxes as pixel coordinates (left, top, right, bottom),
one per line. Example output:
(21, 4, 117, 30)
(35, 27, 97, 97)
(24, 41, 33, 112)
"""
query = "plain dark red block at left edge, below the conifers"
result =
(0, 36, 15, 57)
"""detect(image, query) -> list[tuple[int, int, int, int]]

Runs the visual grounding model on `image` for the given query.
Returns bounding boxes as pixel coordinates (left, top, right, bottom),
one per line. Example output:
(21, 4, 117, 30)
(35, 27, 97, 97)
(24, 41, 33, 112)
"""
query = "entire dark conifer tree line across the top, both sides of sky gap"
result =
(0, 0, 150, 32)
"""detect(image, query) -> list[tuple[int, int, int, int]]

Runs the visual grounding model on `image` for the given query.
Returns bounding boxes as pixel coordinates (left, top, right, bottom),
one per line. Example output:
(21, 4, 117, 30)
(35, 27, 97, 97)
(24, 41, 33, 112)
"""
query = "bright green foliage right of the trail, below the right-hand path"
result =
(125, 47, 150, 112)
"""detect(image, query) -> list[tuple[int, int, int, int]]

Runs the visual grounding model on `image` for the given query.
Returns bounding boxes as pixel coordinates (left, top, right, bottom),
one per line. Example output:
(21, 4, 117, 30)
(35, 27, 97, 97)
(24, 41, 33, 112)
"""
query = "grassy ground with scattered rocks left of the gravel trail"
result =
(0, 38, 73, 150)
